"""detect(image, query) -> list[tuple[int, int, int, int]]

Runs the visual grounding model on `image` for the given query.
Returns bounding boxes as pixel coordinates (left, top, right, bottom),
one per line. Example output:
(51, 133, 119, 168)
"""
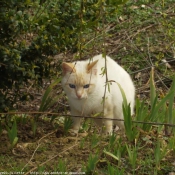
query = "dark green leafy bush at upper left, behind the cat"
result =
(0, 0, 123, 111)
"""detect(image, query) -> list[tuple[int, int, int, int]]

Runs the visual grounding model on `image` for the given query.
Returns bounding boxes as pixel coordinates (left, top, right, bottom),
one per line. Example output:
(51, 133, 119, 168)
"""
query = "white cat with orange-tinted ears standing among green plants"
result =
(62, 55, 135, 133)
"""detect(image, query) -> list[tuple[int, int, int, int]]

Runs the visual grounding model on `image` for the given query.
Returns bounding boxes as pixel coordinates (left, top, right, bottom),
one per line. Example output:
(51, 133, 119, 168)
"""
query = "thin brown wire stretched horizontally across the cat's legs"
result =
(0, 112, 175, 127)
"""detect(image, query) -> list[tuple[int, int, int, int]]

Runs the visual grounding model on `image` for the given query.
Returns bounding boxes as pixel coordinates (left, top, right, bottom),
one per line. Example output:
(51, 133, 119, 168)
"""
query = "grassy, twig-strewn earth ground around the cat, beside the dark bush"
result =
(0, 1, 175, 175)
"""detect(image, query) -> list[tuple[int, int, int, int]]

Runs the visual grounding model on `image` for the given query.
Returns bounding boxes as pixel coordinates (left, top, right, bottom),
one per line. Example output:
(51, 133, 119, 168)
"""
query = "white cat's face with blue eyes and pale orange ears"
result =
(62, 61, 97, 100)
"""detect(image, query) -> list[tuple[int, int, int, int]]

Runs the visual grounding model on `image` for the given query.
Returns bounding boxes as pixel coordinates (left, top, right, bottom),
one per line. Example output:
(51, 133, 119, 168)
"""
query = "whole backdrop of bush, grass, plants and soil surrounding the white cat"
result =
(0, 0, 175, 175)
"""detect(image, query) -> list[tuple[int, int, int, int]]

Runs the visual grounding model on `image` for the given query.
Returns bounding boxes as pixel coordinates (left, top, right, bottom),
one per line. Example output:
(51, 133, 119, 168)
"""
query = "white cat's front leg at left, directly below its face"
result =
(71, 109, 81, 134)
